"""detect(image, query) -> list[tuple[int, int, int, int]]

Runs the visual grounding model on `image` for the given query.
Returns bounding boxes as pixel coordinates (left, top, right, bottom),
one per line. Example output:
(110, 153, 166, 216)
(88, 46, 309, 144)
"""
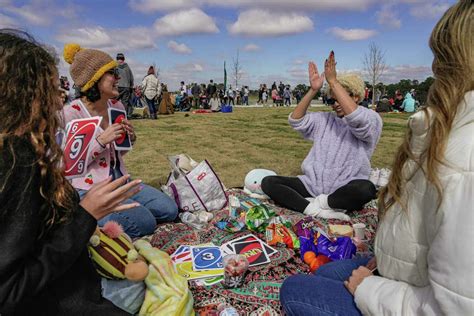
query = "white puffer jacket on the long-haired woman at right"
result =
(355, 91, 474, 315)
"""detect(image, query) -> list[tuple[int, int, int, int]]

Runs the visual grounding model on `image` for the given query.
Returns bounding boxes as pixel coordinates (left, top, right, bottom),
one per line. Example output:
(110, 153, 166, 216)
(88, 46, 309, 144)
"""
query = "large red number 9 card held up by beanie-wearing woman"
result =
(63, 116, 102, 179)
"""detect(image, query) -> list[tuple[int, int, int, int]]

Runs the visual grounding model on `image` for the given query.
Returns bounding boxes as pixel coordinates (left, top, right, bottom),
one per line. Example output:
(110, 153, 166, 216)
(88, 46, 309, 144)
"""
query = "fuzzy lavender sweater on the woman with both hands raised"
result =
(288, 106, 383, 197)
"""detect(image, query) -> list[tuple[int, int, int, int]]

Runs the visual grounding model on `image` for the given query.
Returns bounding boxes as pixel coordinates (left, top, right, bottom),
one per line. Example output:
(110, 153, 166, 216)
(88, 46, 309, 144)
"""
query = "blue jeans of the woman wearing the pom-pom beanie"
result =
(78, 184, 178, 238)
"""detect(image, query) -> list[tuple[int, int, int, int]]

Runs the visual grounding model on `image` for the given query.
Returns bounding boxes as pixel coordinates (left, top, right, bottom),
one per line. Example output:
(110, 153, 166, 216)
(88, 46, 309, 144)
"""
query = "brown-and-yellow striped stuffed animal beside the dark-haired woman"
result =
(88, 221, 148, 281)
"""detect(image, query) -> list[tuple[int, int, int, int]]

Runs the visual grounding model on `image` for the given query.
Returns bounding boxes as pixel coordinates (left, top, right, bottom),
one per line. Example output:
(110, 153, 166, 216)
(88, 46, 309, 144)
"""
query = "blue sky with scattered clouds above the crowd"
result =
(0, 0, 455, 89)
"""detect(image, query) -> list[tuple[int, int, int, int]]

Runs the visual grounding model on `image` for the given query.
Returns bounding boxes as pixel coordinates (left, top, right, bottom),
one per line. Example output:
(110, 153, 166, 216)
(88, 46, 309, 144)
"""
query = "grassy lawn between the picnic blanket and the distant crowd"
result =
(125, 108, 408, 187)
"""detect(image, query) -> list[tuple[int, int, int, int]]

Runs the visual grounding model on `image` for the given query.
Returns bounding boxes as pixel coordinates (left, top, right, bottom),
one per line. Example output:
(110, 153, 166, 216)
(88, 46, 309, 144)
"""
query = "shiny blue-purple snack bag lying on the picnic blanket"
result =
(314, 231, 356, 261)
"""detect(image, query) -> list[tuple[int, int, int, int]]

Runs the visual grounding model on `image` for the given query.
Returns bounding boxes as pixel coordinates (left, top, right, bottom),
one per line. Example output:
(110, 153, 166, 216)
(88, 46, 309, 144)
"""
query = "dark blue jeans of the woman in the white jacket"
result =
(280, 258, 370, 316)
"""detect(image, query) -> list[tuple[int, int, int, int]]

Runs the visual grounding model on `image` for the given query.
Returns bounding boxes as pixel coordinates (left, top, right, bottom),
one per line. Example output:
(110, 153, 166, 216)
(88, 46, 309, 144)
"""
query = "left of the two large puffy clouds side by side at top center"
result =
(153, 9, 219, 36)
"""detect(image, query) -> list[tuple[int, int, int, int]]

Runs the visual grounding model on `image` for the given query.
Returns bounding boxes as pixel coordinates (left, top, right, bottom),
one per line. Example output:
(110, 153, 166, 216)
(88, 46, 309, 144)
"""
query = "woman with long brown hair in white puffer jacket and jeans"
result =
(280, 0, 474, 316)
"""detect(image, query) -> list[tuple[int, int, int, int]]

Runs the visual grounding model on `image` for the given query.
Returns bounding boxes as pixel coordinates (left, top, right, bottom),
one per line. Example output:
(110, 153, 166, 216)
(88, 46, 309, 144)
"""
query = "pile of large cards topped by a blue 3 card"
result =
(171, 244, 224, 286)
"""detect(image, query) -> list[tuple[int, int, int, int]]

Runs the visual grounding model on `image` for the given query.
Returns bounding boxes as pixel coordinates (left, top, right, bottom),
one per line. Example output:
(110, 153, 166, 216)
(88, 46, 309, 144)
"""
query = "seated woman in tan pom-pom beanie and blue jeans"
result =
(64, 44, 178, 237)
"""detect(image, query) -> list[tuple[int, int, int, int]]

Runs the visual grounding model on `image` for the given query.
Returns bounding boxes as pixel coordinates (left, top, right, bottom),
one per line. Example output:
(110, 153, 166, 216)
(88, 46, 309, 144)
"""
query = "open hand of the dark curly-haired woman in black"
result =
(79, 175, 142, 220)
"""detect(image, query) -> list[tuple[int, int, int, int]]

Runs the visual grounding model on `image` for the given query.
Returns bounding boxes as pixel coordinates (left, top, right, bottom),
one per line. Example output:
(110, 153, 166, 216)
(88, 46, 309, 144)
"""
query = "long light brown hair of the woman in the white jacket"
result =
(379, 0, 474, 217)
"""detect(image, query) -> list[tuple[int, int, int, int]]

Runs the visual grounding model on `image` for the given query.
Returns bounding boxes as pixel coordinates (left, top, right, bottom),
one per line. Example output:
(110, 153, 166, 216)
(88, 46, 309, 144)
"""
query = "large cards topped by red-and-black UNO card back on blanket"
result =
(221, 234, 278, 267)
